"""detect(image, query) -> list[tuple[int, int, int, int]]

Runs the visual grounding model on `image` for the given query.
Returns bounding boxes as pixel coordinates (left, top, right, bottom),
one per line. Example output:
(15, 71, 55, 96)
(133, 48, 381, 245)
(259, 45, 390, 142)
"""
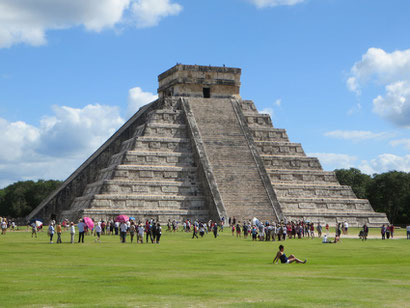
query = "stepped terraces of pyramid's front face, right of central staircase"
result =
(240, 100, 388, 226)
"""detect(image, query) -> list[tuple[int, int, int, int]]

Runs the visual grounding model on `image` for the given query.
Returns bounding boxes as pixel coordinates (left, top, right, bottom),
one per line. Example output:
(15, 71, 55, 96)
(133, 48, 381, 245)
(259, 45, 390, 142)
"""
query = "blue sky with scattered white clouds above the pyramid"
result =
(0, 0, 410, 187)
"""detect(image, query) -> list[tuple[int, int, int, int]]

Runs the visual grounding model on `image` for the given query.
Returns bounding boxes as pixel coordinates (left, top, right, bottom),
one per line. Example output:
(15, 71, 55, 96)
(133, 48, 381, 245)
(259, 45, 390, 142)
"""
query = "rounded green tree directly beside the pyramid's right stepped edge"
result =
(335, 168, 372, 199)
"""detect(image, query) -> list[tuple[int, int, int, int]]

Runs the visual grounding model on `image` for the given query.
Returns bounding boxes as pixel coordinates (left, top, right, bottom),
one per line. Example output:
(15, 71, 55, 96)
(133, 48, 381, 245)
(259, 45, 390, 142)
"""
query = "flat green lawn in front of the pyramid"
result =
(0, 230, 410, 307)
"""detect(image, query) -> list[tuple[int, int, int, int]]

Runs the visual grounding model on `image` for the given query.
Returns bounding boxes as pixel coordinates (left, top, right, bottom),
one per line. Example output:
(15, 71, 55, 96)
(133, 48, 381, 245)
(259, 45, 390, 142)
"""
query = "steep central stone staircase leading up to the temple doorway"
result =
(186, 98, 275, 220)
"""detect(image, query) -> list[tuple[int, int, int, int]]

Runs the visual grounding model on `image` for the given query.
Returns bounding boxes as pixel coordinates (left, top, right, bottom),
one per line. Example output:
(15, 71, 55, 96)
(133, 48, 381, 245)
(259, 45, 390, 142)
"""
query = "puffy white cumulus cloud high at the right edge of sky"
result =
(347, 48, 410, 127)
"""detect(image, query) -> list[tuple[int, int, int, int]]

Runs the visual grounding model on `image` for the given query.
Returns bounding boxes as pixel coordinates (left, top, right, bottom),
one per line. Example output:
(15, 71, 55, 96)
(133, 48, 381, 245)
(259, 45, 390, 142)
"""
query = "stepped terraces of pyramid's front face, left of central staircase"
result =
(62, 99, 209, 221)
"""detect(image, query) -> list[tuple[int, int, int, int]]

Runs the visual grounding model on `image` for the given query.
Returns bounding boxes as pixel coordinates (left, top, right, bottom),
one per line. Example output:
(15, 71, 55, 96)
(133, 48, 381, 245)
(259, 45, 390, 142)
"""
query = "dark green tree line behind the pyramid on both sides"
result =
(0, 168, 410, 224)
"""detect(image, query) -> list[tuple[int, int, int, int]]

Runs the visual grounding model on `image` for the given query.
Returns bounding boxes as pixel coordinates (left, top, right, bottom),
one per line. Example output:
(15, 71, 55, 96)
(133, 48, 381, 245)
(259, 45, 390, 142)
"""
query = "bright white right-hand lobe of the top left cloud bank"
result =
(131, 0, 182, 28)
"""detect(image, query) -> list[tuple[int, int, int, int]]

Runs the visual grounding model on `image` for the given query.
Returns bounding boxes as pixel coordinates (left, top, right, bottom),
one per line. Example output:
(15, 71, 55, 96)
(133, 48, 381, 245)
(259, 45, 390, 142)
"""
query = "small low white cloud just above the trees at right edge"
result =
(358, 154, 410, 174)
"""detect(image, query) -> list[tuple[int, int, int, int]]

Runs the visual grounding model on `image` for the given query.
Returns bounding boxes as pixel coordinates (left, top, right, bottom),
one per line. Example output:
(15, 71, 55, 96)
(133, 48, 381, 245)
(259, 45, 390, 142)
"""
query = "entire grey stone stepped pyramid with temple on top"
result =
(28, 64, 388, 226)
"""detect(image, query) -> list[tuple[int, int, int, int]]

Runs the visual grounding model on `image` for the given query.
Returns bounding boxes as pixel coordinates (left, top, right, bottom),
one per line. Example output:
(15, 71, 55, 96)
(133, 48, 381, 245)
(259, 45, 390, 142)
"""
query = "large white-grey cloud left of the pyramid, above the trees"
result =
(0, 104, 124, 187)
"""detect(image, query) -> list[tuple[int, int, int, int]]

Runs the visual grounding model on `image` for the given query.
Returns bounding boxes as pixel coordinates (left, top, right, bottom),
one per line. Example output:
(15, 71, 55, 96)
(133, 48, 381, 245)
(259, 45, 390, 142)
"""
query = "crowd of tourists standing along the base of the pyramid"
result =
(0, 217, 410, 244)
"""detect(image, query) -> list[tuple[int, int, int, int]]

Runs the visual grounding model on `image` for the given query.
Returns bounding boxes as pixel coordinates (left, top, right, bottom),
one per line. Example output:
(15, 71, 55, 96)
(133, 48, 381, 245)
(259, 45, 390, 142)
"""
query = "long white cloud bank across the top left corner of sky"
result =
(0, 0, 182, 48)
